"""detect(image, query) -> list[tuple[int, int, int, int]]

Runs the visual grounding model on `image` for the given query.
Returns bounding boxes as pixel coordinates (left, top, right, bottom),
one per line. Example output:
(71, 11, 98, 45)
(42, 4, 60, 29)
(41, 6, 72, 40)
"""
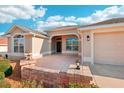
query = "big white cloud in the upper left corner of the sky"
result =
(0, 5, 47, 23)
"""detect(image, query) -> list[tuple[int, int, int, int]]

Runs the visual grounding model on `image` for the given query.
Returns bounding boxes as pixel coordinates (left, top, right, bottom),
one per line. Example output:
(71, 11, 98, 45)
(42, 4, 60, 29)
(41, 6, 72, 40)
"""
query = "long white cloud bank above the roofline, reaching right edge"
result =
(36, 6, 124, 30)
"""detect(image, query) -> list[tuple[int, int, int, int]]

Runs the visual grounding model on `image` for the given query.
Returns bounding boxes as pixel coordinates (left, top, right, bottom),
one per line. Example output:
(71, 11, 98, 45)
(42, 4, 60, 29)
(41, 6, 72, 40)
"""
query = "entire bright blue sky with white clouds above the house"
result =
(0, 5, 124, 35)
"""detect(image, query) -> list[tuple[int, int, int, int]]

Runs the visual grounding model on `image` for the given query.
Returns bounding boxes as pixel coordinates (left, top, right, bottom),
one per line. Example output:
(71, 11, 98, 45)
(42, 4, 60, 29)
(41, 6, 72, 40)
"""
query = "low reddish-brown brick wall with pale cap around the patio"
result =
(21, 65, 93, 87)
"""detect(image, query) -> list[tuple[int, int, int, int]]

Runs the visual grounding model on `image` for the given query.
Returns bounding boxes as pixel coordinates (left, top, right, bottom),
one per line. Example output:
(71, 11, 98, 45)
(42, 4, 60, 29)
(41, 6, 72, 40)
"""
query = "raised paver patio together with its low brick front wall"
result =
(21, 54, 95, 88)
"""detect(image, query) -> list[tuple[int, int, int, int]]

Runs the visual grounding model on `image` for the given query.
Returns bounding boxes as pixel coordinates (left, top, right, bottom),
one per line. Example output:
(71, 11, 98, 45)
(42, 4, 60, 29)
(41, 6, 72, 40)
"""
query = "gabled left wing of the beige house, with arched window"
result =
(5, 25, 49, 59)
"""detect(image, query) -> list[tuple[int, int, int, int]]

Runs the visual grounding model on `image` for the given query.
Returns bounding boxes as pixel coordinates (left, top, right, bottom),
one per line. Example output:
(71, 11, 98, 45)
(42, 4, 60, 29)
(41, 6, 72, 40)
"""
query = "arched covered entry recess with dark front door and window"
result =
(51, 34, 80, 55)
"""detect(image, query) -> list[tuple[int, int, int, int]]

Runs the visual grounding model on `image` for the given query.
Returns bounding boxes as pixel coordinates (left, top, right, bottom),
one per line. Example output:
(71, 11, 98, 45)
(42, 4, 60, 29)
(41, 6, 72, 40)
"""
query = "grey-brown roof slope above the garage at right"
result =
(79, 18, 124, 28)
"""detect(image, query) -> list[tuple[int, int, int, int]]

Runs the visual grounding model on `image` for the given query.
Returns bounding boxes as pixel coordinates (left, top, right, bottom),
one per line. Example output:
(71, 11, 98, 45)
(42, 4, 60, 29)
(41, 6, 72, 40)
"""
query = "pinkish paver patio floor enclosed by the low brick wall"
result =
(36, 54, 78, 71)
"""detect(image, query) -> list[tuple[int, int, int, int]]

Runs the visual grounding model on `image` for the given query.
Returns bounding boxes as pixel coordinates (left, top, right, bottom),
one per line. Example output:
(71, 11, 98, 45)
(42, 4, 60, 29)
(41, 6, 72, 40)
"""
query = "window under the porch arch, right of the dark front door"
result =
(66, 38, 78, 51)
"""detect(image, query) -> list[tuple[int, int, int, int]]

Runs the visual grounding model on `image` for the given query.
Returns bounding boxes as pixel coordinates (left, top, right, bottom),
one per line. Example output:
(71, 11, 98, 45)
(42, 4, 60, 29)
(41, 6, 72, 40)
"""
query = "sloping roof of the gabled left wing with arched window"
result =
(6, 25, 47, 37)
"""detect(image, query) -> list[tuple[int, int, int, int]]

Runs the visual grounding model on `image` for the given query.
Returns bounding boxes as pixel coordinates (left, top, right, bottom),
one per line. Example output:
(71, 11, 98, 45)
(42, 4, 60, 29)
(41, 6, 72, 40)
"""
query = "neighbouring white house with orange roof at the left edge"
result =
(0, 37, 8, 57)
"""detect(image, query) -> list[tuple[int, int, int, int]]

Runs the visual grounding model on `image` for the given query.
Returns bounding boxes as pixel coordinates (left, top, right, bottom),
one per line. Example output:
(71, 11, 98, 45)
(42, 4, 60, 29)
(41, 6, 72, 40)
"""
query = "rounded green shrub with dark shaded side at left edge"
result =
(0, 60, 12, 77)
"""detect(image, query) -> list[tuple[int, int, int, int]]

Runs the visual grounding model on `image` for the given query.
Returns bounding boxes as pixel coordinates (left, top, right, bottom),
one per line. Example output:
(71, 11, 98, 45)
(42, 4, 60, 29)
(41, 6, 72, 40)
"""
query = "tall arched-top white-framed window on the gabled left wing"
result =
(14, 35, 24, 53)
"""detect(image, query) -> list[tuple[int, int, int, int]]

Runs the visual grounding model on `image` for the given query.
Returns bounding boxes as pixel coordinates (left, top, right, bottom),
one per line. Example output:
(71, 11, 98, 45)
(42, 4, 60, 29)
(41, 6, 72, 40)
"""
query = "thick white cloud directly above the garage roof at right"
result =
(76, 6, 124, 24)
